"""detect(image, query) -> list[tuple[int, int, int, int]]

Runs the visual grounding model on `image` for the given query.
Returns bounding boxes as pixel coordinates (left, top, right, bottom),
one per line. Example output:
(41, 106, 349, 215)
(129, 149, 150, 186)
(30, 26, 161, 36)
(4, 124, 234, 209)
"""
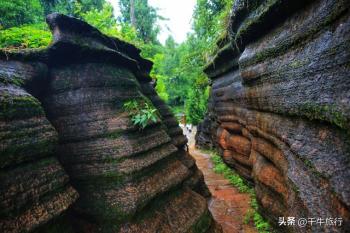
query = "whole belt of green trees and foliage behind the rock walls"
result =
(0, 0, 232, 128)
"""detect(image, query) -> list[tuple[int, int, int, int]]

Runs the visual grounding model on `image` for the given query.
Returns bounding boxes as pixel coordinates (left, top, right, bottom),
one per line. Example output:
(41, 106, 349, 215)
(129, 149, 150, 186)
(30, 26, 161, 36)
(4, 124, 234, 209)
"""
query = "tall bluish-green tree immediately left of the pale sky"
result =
(119, 0, 162, 43)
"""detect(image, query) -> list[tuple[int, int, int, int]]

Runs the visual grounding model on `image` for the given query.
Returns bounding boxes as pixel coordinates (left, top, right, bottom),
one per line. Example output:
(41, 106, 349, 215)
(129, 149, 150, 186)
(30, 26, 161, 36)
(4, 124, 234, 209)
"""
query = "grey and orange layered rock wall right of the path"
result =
(196, 0, 350, 232)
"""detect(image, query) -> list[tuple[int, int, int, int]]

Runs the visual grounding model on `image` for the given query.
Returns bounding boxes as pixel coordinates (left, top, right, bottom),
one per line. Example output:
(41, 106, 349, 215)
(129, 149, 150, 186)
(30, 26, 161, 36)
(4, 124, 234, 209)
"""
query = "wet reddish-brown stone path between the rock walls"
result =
(190, 146, 257, 233)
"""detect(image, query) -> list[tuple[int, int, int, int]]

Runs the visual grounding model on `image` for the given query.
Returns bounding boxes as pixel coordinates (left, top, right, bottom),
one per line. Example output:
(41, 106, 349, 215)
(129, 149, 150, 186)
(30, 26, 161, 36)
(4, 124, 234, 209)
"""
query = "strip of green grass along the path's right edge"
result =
(202, 151, 271, 233)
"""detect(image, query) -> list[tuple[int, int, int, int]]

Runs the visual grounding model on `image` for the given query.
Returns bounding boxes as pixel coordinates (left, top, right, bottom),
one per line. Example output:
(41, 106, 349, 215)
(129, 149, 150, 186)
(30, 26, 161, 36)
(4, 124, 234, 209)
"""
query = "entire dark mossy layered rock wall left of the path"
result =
(0, 14, 221, 233)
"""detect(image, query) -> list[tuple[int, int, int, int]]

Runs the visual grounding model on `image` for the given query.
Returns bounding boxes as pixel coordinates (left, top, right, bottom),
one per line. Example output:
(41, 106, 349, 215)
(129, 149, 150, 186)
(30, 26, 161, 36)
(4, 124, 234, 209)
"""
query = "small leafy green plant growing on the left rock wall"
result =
(123, 99, 160, 130)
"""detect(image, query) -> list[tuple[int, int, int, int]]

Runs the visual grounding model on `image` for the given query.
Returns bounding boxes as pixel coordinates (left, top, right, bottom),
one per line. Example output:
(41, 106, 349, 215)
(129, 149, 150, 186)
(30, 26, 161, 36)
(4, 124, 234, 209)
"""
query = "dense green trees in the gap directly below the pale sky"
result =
(152, 36, 209, 124)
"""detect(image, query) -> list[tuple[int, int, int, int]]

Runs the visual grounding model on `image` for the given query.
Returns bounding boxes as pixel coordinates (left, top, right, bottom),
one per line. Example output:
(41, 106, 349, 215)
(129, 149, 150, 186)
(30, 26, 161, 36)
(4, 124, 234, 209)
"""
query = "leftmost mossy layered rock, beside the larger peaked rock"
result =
(0, 57, 78, 232)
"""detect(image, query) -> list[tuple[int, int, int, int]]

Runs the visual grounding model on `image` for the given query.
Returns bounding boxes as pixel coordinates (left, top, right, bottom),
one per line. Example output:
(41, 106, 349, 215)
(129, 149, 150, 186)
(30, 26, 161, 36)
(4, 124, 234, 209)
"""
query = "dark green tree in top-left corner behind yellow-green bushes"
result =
(0, 0, 43, 29)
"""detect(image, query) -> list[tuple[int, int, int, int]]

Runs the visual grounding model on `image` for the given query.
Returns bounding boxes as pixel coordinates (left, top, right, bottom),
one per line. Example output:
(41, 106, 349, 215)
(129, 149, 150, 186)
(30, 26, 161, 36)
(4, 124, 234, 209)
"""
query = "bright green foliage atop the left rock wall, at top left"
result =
(0, 0, 115, 49)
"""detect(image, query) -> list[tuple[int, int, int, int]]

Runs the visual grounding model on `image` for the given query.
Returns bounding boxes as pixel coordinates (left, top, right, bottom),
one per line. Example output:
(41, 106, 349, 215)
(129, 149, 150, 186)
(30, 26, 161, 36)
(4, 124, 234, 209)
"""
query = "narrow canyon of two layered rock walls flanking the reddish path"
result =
(0, 0, 350, 233)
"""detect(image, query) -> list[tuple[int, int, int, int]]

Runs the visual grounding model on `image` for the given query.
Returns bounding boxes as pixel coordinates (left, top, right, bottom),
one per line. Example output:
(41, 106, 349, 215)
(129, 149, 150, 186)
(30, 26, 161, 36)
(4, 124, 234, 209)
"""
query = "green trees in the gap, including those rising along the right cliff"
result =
(152, 0, 233, 124)
